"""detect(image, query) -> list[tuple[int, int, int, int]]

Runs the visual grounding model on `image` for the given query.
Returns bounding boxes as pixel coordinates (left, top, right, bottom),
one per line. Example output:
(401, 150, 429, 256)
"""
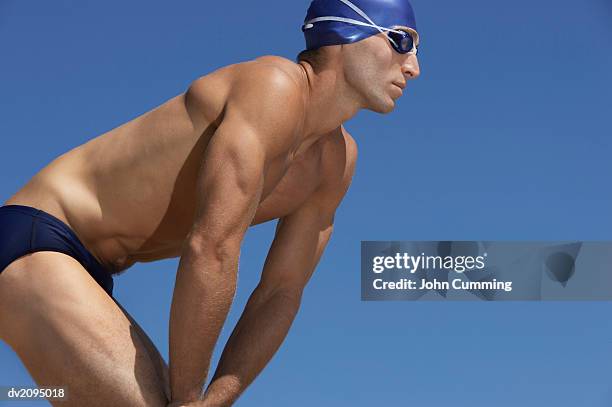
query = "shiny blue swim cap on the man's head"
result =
(302, 0, 418, 50)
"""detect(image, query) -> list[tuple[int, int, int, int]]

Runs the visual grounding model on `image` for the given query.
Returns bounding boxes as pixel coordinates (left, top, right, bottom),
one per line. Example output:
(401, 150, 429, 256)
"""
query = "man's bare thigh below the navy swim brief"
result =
(0, 252, 168, 407)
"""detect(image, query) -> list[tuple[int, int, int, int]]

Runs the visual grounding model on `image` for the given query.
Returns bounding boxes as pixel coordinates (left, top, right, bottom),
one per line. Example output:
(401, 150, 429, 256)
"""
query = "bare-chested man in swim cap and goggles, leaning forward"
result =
(0, 0, 419, 406)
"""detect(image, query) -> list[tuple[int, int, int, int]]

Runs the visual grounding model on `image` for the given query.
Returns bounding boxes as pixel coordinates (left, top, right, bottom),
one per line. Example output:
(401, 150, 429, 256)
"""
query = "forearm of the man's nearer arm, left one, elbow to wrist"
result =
(169, 245, 238, 401)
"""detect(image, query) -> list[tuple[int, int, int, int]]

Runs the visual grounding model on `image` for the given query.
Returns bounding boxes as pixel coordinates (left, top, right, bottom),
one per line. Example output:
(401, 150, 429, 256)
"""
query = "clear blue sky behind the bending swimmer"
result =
(0, 0, 612, 407)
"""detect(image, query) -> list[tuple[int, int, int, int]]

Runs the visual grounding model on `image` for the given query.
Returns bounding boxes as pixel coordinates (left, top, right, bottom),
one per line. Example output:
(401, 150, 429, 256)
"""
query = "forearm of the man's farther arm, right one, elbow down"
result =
(203, 287, 301, 407)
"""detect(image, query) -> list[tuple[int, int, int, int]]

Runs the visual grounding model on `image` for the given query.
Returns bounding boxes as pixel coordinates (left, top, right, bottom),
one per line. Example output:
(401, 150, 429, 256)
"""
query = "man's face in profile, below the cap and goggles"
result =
(342, 27, 420, 113)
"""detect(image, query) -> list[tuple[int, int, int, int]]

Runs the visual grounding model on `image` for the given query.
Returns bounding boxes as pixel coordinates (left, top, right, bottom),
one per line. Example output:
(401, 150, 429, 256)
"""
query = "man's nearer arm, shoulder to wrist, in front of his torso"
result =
(169, 67, 302, 402)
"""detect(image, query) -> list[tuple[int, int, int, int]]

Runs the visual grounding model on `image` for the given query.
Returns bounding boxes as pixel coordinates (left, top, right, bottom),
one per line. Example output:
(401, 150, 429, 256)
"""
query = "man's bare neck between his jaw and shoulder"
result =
(298, 56, 362, 142)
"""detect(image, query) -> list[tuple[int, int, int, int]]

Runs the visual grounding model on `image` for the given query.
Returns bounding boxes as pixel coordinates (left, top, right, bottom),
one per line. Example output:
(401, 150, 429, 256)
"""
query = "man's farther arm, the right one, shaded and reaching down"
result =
(198, 127, 354, 407)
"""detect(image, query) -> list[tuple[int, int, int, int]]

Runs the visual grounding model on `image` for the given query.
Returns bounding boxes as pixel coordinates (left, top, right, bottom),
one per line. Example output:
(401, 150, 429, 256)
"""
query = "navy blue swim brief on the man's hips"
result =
(0, 205, 113, 297)
